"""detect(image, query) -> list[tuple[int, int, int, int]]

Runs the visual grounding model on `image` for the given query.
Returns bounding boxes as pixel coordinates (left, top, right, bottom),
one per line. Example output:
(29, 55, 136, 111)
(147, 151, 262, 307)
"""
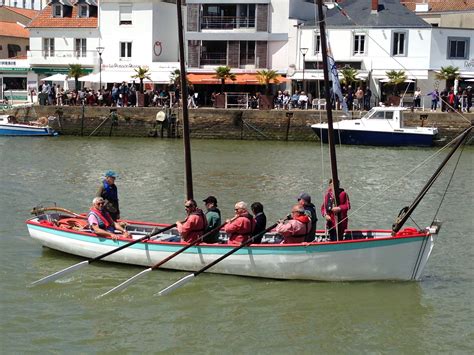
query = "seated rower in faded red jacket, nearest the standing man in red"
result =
(275, 204, 311, 244)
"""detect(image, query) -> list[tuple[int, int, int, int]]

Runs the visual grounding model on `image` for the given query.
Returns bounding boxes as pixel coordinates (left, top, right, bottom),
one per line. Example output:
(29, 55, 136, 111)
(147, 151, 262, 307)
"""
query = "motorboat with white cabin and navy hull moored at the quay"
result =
(311, 107, 438, 147)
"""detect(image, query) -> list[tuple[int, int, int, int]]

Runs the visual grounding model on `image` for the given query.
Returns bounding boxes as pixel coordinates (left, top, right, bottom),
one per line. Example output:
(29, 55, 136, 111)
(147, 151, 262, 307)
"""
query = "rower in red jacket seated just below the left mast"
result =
(176, 200, 207, 243)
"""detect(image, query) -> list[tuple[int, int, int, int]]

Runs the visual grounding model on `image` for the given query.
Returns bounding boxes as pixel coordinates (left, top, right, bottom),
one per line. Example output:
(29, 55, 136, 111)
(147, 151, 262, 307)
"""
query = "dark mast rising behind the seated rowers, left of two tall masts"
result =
(176, 0, 194, 200)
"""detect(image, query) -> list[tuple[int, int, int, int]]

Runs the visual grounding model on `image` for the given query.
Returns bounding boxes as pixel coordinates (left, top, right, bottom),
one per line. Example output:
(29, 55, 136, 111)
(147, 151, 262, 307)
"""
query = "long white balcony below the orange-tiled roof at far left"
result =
(27, 50, 99, 67)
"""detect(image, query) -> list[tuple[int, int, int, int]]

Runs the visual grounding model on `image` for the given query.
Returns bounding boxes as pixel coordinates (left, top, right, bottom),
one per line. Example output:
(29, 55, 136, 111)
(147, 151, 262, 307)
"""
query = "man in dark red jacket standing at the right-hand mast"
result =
(321, 179, 351, 241)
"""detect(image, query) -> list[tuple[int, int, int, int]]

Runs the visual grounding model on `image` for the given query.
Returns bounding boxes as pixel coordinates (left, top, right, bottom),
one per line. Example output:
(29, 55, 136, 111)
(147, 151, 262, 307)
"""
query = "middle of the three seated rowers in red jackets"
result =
(224, 201, 255, 245)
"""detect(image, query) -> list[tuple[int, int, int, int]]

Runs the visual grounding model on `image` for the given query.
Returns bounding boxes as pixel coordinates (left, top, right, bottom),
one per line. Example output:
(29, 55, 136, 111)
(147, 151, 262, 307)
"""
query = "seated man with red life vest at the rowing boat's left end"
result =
(87, 197, 130, 240)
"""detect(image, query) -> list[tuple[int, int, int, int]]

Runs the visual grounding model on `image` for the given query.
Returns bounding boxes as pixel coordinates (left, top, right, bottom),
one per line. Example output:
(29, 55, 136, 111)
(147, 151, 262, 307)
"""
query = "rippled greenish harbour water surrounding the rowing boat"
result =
(0, 137, 474, 354)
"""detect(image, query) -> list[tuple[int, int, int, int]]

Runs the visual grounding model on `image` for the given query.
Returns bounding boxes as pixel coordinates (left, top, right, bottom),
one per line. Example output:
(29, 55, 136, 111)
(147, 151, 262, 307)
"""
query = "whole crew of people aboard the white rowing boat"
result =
(88, 170, 351, 245)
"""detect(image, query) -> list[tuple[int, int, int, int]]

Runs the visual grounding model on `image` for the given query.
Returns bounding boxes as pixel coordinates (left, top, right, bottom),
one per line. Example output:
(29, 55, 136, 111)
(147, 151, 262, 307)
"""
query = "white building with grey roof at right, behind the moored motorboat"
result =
(298, 0, 474, 104)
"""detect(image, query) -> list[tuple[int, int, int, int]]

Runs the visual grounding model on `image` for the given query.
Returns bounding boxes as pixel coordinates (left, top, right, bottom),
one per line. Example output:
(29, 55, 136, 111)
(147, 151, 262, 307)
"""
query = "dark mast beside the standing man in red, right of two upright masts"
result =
(318, 0, 342, 225)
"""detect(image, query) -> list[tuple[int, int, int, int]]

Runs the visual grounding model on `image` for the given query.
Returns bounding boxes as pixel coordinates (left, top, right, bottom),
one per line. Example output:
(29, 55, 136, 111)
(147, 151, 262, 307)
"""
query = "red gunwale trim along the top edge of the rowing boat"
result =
(25, 219, 430, 248)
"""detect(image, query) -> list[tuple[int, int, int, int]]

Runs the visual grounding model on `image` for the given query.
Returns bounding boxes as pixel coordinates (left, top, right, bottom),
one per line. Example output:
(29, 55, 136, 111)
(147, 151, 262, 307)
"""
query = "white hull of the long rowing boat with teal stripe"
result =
(27, 220, 433, 281)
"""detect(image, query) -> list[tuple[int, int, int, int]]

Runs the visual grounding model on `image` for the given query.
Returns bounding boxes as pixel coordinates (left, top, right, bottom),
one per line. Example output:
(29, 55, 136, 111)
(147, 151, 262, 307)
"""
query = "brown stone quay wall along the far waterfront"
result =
(12, 106, 474, 144)
